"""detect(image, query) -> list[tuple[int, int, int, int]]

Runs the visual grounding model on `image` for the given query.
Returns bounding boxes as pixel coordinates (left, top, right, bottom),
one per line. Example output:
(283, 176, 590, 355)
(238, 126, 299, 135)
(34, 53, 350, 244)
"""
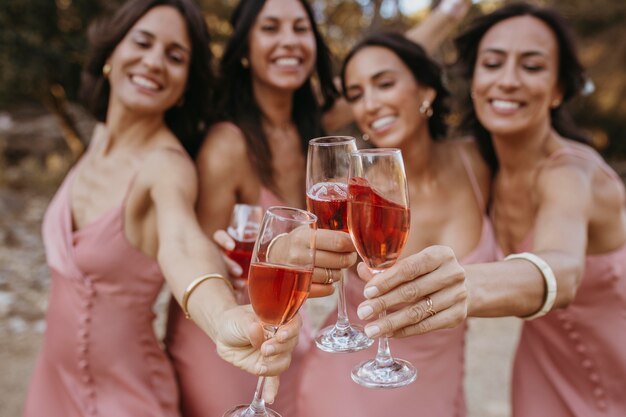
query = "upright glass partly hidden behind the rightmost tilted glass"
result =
(306, 136, 374, 352)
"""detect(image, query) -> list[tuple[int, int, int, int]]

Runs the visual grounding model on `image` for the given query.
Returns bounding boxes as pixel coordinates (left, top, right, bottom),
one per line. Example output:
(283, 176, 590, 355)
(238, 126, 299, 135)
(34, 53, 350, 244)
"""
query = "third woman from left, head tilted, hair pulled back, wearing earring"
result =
(299, 33, 495, 417)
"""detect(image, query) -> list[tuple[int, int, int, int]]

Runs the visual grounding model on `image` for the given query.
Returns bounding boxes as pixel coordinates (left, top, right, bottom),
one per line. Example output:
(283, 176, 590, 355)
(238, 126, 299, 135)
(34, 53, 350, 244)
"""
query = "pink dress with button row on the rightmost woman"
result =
(502, 148, 626, 417)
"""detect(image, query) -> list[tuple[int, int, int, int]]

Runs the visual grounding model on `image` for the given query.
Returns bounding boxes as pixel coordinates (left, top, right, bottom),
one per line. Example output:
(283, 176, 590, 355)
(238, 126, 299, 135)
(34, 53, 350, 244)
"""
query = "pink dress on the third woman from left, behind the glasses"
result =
(295, 148, 496, 417)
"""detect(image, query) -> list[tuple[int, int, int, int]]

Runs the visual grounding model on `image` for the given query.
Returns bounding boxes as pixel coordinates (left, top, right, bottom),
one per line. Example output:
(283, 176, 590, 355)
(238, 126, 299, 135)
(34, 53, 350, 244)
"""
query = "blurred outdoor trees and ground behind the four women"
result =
(0, 0, 626, 417)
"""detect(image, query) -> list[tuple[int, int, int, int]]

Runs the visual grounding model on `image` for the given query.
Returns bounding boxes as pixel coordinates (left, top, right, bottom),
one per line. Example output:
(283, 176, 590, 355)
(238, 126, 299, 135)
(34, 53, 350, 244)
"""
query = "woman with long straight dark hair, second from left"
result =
(167, 0, 467, 417)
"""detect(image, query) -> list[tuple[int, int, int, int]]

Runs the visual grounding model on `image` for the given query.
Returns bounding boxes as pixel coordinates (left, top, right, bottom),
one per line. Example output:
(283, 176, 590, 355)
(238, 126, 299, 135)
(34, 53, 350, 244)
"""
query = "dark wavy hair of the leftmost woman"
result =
(80, 0, 213, 157)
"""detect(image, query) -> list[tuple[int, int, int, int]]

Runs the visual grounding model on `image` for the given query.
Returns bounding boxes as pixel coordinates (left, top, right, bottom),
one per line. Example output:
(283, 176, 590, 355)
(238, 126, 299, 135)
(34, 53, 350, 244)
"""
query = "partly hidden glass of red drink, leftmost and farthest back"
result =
(224, 204, 263, 304)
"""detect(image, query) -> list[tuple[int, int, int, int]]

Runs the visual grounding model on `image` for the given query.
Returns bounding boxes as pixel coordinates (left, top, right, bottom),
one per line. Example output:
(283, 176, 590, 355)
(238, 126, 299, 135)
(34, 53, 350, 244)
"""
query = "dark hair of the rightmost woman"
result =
(455, 2, 590, 174)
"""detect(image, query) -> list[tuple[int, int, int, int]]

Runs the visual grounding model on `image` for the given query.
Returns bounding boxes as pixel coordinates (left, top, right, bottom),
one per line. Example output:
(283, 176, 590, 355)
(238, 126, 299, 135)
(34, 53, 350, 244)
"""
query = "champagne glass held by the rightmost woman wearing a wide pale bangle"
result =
(348, 148, 417, 388)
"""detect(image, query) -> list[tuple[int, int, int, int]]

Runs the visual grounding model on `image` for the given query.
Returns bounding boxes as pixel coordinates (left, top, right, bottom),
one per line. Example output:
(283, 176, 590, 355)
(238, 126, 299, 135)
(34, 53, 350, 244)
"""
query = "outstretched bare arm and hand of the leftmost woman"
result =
(149, 151, 300, 400)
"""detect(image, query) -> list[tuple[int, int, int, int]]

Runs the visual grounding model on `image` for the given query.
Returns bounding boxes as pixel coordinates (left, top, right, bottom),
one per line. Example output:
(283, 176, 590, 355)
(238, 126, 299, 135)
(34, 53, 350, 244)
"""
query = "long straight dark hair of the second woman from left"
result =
(215, 0, 339, 191)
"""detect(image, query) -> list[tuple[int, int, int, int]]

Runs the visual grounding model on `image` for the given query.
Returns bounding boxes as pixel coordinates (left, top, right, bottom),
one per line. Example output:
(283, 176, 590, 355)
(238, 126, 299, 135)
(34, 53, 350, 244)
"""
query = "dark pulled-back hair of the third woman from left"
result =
(341, 32, 450, 139)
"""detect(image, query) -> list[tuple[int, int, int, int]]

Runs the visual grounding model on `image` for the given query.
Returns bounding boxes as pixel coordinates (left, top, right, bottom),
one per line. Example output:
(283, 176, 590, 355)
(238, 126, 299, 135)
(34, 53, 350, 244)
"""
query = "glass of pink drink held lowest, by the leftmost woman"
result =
(223, 206, 317, 417)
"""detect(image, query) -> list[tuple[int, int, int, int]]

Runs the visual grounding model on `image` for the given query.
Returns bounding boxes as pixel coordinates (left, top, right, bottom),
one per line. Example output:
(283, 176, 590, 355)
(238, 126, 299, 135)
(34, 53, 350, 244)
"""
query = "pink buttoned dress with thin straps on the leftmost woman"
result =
(24, 164, 180, 417)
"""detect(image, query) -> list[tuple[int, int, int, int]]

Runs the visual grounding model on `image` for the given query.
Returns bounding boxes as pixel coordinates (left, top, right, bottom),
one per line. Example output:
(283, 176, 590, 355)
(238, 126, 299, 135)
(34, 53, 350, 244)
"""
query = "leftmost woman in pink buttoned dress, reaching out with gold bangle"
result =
(24, 0, 299, 417)
